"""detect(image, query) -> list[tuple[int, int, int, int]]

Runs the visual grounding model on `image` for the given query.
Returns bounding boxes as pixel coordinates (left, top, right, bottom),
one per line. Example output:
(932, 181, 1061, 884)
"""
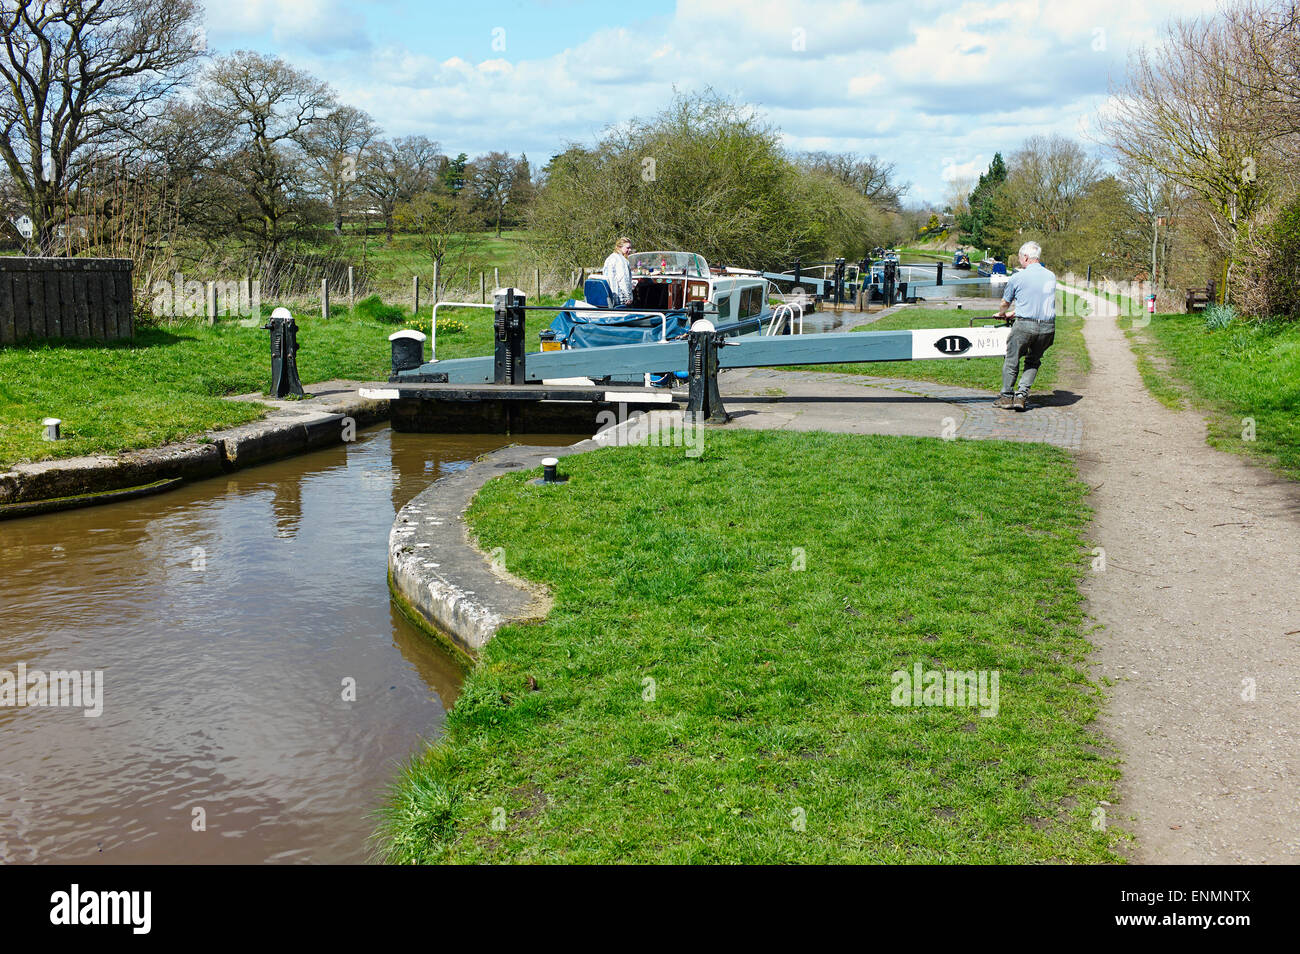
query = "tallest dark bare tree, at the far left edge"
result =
(0, 0, 203, 248)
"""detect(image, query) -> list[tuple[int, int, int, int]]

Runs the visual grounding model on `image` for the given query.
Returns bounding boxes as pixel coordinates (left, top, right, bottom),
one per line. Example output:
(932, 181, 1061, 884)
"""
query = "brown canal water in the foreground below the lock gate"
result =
(0, 428, 577, 863)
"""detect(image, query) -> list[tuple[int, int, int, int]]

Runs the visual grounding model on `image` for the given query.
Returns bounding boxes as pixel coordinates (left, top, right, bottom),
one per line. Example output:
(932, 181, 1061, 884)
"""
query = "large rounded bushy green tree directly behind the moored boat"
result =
(529, 91, 875, 266)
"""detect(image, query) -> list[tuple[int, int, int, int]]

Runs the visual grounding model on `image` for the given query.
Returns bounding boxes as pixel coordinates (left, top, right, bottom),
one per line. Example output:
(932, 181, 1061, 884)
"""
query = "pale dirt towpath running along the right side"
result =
(1078, 287, 1300, 863)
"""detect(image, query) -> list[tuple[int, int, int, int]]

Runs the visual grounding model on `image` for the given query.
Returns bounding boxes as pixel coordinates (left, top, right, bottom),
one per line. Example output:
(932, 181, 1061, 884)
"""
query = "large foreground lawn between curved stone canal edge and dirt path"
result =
(377, 430, 1117, 863)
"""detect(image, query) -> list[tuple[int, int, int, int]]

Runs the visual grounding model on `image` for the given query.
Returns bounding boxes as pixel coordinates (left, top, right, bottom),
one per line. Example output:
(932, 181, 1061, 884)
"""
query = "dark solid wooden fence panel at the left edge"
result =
(0, 256, 135, 344)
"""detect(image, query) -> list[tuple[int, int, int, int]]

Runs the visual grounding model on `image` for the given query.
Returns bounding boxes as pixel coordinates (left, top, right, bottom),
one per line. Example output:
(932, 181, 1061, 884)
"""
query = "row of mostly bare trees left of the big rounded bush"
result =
(0, 0, 534, 272)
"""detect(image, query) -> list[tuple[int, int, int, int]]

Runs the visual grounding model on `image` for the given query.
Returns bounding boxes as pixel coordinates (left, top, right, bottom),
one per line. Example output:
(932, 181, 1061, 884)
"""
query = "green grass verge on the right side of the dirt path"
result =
(1121, 315, 1300, 480)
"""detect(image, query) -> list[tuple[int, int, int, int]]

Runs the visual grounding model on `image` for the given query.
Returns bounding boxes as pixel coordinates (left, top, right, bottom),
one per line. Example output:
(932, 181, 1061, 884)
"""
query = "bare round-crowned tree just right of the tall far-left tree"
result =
(199, 51, 334, 252)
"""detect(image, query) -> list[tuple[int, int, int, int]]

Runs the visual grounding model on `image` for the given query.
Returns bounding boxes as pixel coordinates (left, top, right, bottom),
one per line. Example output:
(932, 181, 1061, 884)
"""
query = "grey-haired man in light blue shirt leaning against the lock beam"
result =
(993, 242, 1056, 411)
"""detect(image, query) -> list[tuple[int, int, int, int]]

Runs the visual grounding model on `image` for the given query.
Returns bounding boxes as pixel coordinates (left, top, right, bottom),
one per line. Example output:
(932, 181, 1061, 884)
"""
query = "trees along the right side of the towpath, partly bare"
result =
(950, 0, 1300, 318)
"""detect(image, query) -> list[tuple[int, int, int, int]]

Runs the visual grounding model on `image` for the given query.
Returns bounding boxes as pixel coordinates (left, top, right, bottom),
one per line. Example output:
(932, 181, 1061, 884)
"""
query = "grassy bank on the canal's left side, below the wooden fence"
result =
(0, 295, 569, 465)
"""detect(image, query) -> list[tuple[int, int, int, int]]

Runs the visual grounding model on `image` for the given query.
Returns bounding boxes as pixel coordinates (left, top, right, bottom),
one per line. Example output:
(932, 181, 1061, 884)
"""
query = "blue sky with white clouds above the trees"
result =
(205, 0, 1216, 204)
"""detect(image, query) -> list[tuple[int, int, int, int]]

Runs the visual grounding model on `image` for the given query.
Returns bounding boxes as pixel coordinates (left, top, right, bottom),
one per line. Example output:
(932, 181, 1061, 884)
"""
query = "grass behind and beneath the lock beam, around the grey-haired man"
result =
(792, 292, 1091, 394)
